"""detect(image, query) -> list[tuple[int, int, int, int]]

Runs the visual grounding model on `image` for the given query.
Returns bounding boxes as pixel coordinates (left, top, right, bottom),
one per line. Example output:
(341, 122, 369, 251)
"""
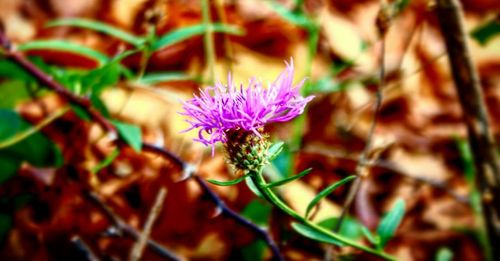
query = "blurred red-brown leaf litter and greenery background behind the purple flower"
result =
(0, 0, 500, 260)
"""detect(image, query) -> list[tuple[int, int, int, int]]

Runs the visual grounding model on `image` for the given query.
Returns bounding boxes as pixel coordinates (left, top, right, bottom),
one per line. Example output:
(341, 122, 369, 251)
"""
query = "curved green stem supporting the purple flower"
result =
(250, 171, 396, 261)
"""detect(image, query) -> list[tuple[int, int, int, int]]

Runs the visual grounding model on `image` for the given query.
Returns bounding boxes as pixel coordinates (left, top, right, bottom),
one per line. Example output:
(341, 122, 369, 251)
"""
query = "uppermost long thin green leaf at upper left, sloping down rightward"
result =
(45, 18, 145, 46)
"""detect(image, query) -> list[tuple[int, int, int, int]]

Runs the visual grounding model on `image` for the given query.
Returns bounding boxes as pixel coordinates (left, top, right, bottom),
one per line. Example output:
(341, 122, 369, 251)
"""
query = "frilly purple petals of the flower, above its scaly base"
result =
(181, 60, 313, 151)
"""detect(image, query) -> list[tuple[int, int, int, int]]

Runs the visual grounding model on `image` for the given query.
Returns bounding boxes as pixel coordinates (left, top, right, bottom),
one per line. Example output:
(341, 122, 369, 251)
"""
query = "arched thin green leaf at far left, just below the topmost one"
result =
(18, 40, 109, 65)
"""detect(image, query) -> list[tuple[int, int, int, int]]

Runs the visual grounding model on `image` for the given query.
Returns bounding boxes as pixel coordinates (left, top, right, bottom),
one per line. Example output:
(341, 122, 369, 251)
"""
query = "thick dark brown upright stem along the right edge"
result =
(435, 0, 500, 260)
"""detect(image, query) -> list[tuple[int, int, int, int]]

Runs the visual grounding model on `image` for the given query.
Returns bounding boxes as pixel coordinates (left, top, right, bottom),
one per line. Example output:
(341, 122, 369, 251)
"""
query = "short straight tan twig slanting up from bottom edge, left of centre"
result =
(130, 187, 167, 261)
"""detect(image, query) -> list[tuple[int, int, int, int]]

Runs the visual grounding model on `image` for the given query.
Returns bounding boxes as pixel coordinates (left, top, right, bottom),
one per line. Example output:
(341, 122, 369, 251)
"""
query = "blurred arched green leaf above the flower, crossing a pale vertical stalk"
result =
(152, 23, 245, 50)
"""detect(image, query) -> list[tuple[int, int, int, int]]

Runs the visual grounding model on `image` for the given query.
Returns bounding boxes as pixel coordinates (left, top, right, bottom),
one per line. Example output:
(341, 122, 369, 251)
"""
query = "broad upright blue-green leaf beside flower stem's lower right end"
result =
(377, 199, 405, 248)
